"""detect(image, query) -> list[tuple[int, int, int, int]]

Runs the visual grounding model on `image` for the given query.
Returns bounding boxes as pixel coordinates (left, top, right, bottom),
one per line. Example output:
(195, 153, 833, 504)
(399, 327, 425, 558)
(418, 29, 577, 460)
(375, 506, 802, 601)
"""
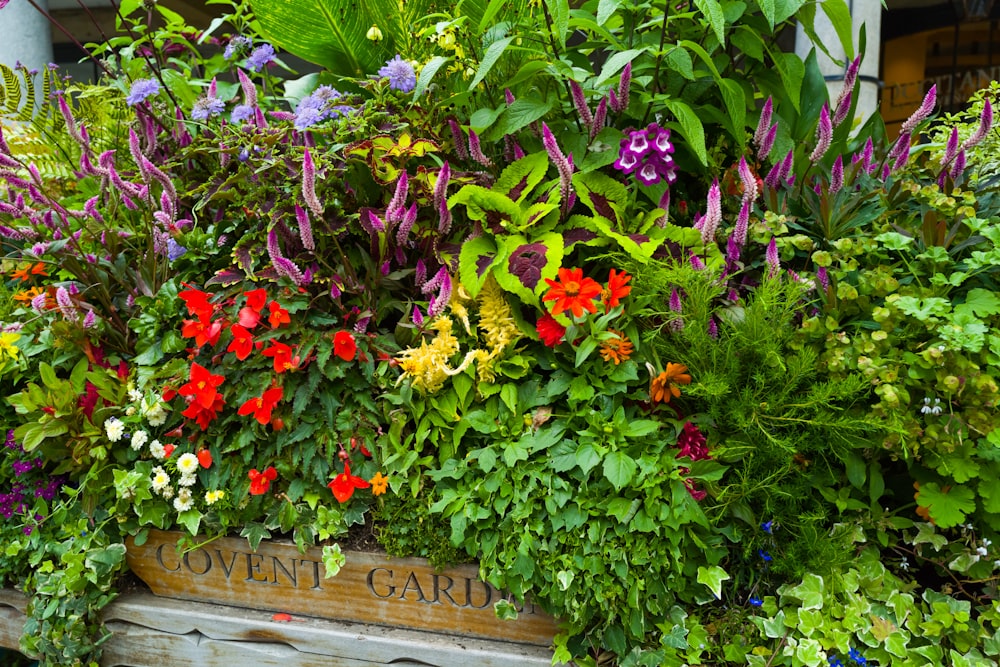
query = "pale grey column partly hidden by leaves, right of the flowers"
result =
(795, 0, 882, 120)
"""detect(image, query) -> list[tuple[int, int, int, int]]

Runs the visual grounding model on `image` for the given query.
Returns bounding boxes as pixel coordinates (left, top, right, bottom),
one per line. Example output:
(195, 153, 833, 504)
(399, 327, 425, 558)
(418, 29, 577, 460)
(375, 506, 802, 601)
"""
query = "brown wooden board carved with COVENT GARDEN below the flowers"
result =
(126, 530, 557, 647)
